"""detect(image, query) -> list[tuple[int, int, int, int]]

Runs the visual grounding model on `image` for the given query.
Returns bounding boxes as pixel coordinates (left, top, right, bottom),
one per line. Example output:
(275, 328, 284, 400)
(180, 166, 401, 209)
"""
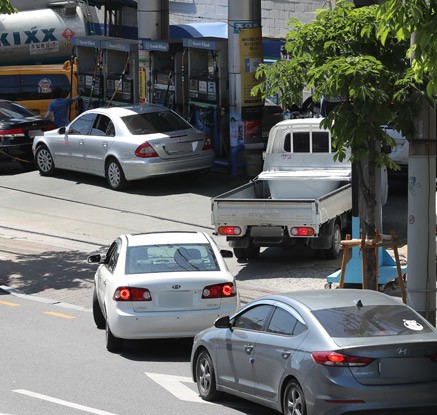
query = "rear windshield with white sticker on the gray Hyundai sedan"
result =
(313, 305, 432, 337)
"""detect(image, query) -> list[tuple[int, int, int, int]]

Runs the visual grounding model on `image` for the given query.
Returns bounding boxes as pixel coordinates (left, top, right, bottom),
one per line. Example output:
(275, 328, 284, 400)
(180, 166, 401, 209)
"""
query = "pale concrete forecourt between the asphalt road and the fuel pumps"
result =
(0, 165, 407, 308)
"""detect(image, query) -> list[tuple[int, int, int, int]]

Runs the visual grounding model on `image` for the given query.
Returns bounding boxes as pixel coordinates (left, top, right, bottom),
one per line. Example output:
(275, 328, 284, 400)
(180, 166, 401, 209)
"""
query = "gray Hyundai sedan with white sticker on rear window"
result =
(191, 289, 437, 415)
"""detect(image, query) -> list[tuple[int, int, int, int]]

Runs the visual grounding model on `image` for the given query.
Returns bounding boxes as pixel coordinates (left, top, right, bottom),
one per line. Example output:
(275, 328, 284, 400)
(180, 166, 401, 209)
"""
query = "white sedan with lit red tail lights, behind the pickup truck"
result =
(88, 231, 240, 352)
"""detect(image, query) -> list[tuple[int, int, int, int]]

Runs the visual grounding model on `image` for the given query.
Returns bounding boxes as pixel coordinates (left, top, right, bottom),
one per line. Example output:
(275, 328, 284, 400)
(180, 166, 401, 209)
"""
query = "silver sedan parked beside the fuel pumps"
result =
(32, 104, 214, 190)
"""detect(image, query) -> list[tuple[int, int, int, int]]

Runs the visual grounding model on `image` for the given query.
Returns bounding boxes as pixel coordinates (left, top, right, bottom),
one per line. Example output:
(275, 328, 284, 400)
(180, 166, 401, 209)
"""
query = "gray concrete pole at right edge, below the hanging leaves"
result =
(407, 101, 436, 325)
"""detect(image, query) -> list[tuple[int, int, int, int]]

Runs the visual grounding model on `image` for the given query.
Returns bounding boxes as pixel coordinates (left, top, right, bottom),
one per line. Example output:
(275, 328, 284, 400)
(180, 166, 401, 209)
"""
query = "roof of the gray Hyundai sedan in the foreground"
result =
(263, 289, 400, 310)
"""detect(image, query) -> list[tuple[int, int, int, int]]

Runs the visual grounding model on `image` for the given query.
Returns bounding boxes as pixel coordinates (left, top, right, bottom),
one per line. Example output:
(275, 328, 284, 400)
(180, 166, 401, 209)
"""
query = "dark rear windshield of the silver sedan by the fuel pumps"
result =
(122, 111, 192, 135)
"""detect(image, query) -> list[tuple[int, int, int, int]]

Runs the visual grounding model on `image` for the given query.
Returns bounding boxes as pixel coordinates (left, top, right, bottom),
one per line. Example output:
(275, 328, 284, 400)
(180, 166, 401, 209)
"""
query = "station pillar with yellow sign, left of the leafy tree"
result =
(228, 0, 263, 161)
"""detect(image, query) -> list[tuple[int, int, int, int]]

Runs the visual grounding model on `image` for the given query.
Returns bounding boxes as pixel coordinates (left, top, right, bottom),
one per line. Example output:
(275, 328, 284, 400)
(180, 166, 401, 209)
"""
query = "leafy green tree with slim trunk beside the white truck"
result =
(252, 0, 420, 288)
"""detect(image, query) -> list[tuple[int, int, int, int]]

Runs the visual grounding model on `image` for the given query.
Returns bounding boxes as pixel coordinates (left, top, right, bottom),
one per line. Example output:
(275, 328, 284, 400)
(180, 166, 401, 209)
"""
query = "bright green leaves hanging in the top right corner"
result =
(378, 0, 437, 98)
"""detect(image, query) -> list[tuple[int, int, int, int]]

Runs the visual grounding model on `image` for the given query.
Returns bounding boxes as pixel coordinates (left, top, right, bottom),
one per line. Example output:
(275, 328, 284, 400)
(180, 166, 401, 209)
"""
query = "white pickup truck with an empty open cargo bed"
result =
(211, 118, 352, 259)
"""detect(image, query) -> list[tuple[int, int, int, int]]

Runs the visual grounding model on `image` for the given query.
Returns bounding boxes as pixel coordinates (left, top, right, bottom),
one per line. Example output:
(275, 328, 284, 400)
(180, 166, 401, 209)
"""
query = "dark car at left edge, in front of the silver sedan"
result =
(0, 99, 56, 164)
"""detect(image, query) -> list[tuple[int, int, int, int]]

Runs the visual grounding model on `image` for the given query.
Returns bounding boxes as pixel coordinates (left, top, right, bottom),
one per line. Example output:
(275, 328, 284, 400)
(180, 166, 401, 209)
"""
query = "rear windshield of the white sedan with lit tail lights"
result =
(126, 244, 220, 274)
